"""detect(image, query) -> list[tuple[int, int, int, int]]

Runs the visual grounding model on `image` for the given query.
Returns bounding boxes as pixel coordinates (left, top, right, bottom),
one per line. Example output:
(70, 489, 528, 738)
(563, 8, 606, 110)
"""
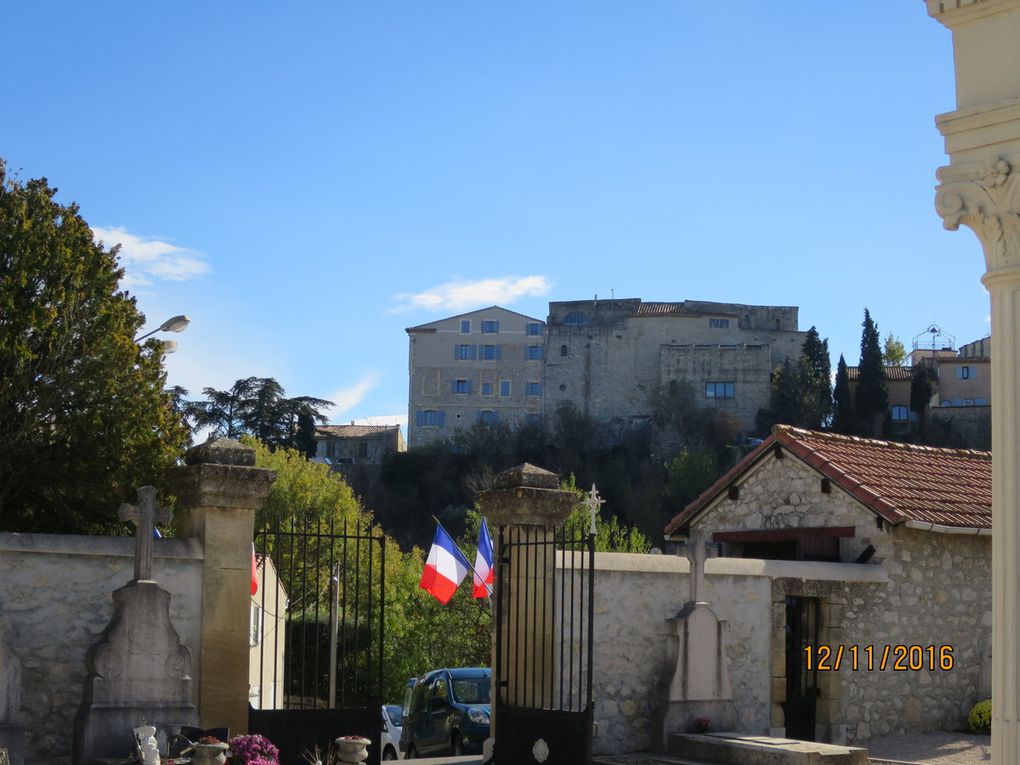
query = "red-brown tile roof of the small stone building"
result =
(666, 425, 991, 534)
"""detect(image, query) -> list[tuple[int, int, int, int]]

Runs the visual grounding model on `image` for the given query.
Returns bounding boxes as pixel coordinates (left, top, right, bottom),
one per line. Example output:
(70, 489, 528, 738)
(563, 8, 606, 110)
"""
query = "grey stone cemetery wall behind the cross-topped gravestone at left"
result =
(0, 533, 202, 765)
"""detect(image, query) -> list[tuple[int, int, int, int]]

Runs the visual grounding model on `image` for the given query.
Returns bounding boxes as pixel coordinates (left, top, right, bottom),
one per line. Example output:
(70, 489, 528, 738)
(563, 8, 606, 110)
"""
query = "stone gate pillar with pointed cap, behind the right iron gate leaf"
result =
(477, 463, 577, 758)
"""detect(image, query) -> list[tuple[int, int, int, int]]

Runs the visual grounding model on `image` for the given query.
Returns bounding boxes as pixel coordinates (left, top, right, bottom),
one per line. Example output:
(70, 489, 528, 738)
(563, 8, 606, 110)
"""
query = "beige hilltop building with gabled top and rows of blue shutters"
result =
(407, 306, 546, 447)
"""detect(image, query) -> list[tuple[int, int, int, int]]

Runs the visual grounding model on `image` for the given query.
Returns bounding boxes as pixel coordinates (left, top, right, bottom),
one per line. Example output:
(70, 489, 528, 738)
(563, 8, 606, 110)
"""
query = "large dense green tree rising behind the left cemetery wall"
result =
(0, 160, 188, 532)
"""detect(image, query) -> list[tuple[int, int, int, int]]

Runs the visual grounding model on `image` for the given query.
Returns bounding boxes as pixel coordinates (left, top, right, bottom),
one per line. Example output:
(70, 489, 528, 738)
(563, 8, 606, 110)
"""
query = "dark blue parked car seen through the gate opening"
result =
(400, 667, 492, 759)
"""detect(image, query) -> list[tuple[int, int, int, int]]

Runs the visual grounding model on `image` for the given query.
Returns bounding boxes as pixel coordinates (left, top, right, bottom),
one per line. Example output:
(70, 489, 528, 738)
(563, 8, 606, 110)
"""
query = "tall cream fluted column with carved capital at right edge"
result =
(927, 0, 1020, 765)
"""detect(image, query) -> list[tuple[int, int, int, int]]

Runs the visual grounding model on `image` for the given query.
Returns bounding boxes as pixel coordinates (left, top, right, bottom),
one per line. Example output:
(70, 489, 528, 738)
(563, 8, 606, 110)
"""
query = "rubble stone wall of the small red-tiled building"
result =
(695, 456, 991, 743)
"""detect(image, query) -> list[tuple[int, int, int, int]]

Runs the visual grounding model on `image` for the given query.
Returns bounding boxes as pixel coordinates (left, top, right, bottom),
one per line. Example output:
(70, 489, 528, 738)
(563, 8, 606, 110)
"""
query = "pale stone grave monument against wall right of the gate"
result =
(660, 531, 736, 749)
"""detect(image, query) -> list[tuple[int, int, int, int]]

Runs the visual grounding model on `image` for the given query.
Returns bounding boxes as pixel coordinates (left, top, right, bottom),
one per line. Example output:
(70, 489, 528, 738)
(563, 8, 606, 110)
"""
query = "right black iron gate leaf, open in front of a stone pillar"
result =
(494, 526, 595, 765)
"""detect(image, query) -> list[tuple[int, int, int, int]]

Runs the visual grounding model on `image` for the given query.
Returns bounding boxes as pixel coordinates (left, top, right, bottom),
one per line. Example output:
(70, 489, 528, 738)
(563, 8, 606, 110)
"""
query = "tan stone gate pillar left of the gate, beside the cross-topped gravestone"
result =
(170, 439, 275, 735)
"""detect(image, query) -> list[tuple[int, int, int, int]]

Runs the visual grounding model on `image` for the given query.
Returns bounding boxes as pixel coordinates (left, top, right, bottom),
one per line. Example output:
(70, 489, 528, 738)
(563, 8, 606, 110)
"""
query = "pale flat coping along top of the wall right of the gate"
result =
(595, 553, 889, 583)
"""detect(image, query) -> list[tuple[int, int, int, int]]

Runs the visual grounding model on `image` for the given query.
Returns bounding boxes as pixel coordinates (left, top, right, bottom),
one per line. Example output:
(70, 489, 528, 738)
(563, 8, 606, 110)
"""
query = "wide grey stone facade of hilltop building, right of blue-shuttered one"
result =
(545, 299, 806, 430)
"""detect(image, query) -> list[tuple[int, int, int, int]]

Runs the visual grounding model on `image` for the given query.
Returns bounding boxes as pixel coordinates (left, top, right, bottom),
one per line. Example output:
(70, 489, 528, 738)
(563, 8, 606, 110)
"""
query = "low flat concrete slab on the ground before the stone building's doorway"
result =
(669, 732, 868, 765)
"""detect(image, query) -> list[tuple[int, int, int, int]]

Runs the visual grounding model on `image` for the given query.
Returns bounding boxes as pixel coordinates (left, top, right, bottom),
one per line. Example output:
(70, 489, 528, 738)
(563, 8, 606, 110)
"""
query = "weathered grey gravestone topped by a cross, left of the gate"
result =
(73, 487, 198, 765)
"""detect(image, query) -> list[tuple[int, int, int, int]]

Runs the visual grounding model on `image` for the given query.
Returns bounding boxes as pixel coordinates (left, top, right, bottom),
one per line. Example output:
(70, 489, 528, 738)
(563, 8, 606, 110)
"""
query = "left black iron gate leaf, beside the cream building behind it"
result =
(249, 520, 386, 765)
